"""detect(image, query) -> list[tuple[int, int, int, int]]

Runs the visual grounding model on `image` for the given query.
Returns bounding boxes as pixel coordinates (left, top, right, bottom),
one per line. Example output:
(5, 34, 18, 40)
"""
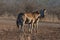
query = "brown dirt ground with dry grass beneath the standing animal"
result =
(0, 19, 60, 40)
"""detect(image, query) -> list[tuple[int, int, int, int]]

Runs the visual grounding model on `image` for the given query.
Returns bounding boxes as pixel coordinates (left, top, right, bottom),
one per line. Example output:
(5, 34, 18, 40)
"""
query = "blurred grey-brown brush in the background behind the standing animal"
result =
(0, 0, 60, 21)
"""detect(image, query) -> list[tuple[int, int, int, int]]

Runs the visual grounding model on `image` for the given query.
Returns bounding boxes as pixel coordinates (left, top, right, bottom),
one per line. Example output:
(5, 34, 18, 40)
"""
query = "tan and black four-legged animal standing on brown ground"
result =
(16, 9, 46, 30)
